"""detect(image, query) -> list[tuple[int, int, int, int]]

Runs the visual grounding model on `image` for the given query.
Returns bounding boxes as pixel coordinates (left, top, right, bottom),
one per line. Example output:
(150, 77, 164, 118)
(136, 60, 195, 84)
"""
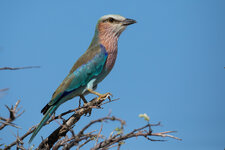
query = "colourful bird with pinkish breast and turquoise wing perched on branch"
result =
(29, 14, 136, 143)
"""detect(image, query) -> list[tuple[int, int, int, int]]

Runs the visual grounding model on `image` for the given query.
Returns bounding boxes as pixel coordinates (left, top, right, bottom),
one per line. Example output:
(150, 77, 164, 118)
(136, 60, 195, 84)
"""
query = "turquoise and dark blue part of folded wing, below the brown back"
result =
(48, 44, 108, 106)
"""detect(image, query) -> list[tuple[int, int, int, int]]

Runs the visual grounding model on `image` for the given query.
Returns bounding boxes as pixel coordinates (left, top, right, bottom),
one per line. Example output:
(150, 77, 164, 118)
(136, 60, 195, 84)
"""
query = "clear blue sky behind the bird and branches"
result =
(0, 0, 225, 150)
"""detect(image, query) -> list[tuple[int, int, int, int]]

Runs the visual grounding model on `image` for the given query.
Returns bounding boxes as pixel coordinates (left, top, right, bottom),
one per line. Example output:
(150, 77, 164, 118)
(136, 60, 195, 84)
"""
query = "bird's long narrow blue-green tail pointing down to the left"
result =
(29, 105, 58, 143)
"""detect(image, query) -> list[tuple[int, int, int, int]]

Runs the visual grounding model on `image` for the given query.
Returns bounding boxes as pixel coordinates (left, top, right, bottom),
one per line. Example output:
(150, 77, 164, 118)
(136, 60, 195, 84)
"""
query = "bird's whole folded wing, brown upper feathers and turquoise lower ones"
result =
(49, 44, 108, 106)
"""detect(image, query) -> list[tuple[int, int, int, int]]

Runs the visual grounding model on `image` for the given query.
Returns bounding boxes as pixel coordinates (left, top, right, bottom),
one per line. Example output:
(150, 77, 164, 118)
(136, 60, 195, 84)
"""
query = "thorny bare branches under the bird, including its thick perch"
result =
(1, 96, 181, 150)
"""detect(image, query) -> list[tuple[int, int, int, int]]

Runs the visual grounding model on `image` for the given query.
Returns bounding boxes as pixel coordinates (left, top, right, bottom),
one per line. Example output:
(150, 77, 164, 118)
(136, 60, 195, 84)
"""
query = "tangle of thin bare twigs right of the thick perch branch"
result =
(44, 116, 181, 150)
